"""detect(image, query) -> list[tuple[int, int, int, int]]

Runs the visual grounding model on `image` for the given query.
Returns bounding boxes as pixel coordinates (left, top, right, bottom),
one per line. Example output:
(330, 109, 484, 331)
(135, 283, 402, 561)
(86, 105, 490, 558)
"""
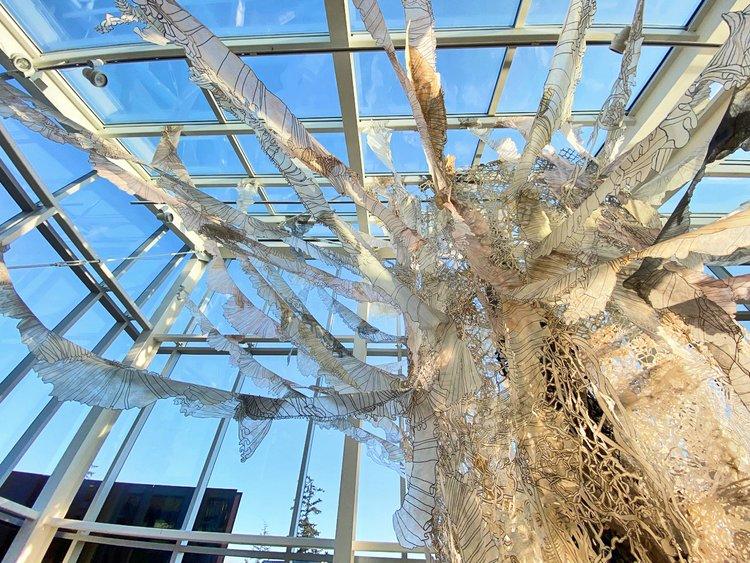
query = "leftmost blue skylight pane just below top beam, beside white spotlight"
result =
(61, 60, 215, 125)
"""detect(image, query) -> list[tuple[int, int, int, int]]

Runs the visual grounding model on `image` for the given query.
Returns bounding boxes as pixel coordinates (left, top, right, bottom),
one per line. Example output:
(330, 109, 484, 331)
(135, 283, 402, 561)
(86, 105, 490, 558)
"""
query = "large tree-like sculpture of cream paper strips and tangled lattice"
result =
(0, 0, 750, 562)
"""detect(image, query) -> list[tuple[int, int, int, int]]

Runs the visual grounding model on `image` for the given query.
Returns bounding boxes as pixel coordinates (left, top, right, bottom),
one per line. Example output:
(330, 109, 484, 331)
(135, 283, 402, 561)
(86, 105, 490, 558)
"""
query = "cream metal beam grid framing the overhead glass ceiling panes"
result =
(0, 0, 712, 220)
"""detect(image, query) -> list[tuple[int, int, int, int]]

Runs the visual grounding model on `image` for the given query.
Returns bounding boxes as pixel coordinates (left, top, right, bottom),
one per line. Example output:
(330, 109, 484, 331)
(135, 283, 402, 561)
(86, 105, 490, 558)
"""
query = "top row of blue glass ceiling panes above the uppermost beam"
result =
(2, 0, 701, 52)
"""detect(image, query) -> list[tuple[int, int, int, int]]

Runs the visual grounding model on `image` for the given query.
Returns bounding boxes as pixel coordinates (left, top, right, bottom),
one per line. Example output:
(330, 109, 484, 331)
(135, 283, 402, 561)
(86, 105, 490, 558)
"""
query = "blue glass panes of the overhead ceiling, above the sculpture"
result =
(2, 0, 698, 220)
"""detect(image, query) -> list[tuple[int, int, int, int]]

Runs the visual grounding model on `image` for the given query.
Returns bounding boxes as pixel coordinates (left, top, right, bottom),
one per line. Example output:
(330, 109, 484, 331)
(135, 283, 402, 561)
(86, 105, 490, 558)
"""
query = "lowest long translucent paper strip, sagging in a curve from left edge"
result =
(0, 254, 408, 421)
